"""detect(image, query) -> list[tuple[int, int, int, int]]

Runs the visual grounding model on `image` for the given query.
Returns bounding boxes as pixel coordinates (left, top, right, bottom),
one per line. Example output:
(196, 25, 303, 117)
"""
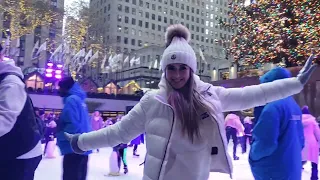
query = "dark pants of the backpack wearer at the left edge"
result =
(0, 156, 42, 180)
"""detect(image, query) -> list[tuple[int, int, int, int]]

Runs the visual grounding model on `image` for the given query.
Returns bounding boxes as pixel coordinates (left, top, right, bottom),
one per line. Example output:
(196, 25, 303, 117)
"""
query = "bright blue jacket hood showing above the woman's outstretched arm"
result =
(259, 67, 291, 83)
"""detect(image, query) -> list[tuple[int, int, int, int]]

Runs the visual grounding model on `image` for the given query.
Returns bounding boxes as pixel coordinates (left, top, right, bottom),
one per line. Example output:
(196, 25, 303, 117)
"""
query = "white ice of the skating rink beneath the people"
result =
(35, 143, 311, 180)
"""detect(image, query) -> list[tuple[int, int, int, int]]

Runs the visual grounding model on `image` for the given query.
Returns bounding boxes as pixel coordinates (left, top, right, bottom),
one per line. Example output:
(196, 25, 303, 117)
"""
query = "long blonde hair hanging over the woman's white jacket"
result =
(168, 71, 208, 142)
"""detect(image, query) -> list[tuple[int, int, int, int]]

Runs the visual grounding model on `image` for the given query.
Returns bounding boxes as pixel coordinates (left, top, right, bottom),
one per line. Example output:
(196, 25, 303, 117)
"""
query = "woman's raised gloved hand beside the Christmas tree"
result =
(297, 55, 318, 85)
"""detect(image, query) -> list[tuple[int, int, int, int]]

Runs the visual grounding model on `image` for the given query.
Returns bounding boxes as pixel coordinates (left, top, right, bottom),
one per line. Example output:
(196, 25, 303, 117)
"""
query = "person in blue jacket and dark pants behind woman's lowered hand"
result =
(57, 77, 91, 180)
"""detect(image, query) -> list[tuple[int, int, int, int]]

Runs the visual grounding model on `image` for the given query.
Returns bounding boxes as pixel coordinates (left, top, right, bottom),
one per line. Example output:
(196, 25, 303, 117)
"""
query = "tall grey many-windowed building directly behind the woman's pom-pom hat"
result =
(90, 0, 235, 81)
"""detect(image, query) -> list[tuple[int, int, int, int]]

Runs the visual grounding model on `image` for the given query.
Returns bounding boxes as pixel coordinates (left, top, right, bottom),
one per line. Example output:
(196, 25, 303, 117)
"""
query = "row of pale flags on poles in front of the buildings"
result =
(4, 36, 207, 73)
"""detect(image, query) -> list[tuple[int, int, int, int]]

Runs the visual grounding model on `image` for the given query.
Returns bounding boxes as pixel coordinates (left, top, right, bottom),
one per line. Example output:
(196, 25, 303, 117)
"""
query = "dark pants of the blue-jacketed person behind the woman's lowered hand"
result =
(63, 154, 88, 180)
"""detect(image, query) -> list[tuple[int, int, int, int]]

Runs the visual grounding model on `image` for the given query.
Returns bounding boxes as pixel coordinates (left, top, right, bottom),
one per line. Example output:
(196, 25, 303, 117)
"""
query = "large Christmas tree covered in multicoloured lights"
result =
(224, 0, 320, 67)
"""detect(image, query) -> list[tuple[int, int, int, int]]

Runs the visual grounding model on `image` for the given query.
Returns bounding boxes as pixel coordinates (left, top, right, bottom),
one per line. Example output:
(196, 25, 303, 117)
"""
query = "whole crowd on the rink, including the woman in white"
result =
(0, 24, 319, 180)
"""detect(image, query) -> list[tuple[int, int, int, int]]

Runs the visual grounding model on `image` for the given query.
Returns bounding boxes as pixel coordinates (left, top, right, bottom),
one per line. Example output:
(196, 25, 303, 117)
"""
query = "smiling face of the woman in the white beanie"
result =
(166, 63, 191, 89)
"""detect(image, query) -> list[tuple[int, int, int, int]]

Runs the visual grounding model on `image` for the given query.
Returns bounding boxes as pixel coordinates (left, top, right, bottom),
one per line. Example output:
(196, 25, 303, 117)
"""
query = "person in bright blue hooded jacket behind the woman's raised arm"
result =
(249, 68, 304, 180)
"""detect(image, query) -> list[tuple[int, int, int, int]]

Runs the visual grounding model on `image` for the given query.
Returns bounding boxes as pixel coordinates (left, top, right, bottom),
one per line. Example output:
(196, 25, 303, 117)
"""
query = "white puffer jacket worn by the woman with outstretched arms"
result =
(78, 75, 303, 180)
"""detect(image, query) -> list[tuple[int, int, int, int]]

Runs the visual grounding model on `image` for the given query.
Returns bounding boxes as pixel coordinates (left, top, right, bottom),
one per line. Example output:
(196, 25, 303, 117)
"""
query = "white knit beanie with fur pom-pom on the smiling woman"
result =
(160, 24, 197, 72)
